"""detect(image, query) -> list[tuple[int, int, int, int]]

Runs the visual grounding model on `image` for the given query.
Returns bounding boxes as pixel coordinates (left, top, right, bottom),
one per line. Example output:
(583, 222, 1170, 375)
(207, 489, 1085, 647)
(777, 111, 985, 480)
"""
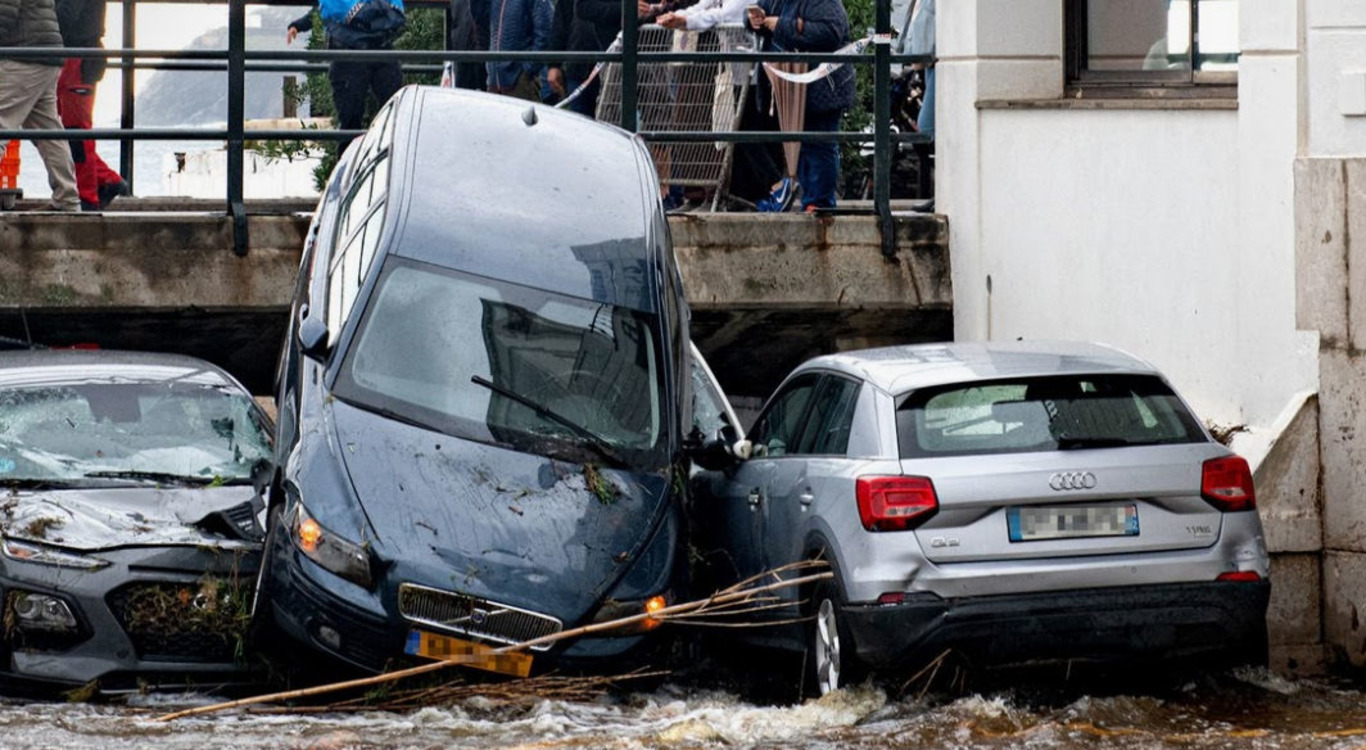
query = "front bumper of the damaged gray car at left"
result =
(0, 546, 260, 691)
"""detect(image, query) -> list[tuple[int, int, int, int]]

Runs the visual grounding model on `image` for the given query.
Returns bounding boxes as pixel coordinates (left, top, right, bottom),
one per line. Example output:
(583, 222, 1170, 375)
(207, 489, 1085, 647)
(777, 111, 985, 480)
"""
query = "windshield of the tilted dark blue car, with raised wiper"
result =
(335, 258, 668, 466)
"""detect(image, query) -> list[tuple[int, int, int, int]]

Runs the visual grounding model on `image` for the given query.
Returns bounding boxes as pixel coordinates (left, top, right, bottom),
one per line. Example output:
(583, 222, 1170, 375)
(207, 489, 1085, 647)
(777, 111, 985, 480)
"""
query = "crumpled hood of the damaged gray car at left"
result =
(0, 485, 255, 551)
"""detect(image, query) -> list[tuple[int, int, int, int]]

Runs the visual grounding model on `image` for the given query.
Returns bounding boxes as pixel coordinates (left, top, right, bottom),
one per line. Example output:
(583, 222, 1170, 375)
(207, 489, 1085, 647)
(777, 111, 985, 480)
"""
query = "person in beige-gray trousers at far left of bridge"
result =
(0, 0, 81, 210)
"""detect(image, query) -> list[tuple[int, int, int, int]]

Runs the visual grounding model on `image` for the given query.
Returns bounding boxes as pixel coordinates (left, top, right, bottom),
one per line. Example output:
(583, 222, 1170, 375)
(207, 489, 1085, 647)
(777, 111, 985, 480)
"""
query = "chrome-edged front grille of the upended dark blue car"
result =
(399, 583, 564, 652)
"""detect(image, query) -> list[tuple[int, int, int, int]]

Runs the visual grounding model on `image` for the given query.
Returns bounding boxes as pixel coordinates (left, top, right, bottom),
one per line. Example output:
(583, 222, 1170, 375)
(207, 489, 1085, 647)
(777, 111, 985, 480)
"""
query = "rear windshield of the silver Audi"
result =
(896, 374, 1206, 458)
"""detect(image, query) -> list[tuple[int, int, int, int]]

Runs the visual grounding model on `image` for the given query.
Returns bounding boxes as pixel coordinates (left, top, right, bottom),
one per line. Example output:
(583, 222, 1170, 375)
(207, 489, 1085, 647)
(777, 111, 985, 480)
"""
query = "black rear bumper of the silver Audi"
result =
(844, 581, 1270, 669)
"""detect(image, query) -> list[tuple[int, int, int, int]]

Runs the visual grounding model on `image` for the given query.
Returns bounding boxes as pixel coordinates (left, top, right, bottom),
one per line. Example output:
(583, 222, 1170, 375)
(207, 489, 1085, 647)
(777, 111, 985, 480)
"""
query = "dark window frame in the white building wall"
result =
(1063, 0, 1242, 98)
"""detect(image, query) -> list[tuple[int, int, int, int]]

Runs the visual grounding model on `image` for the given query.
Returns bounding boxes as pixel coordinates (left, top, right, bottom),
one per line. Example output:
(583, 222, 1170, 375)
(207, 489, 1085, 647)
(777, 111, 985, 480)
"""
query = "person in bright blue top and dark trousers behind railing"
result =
(284, 0, 406, 153)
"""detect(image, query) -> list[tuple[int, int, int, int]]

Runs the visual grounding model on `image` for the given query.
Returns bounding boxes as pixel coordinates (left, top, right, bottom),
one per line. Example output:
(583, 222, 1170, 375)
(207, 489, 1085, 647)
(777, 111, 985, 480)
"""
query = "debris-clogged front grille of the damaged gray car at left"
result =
(105, 579, 251, 663)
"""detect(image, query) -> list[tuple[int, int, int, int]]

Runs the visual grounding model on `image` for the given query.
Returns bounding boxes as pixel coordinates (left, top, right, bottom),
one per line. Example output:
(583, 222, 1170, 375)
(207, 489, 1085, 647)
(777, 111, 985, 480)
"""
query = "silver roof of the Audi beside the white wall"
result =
(792, 342, 1160, 393)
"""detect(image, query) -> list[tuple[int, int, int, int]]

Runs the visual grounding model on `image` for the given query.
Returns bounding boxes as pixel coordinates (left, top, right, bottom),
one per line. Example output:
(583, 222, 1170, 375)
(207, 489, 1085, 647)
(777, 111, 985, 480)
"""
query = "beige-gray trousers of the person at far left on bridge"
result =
(0, 60, 81, 210)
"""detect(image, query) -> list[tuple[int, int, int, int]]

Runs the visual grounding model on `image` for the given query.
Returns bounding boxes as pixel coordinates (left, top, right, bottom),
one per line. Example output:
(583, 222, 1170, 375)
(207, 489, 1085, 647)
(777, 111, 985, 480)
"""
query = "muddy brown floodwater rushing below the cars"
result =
(0, 669, 1366, 750)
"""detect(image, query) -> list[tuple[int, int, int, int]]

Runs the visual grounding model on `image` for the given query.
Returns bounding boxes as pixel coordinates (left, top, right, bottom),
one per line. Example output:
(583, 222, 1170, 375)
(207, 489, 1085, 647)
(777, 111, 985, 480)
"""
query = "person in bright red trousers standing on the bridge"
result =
(57, 0, 130, 210)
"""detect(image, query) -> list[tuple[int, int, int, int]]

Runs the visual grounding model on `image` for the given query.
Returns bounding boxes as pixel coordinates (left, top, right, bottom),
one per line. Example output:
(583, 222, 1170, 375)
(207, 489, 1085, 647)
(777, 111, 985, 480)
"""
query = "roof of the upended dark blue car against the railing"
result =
(389, 86, 671, 311)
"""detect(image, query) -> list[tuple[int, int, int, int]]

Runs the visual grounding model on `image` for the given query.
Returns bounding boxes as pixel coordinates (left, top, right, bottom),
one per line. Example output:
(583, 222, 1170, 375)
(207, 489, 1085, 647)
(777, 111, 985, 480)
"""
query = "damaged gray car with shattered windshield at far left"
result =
(0, 351, 272, 691)
